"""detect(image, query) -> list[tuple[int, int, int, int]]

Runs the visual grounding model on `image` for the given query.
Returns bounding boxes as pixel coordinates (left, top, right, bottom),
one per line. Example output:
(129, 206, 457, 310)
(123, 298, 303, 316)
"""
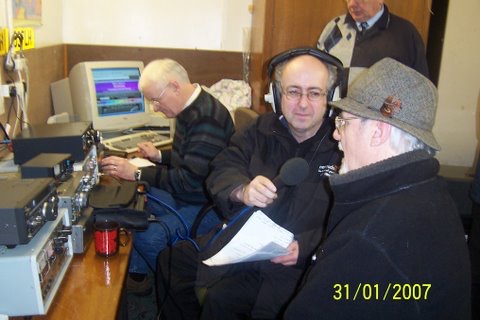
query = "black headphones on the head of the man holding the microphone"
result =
(265, 47, 344, 115)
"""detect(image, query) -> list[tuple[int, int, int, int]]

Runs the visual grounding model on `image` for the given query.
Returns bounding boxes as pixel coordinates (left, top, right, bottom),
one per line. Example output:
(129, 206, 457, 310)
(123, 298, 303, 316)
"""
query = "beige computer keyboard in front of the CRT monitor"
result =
(102, 131, 172, 153)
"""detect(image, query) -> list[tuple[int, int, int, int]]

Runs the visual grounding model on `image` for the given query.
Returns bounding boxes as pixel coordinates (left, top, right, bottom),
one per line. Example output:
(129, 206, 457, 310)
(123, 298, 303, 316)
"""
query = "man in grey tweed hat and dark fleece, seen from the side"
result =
(285, 58, 471, 319)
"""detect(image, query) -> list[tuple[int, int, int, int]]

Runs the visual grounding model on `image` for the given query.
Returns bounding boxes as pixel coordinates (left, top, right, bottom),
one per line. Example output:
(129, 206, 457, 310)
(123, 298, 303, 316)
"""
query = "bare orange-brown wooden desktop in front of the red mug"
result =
(33, 236, 132, 320)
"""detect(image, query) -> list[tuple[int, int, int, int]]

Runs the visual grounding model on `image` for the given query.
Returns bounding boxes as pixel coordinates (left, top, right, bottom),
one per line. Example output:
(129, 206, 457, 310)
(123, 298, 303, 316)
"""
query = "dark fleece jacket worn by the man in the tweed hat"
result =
(285, 151, 470, 320)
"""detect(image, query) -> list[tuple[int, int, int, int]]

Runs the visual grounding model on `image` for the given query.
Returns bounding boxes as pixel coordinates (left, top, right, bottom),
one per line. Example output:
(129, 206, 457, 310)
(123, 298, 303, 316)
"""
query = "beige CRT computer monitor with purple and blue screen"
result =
(69, 61, 149, 131)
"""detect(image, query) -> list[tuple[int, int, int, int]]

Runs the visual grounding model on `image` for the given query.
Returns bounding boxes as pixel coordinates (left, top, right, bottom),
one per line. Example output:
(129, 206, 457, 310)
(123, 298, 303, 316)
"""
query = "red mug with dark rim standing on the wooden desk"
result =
(94, 220, 129, 257)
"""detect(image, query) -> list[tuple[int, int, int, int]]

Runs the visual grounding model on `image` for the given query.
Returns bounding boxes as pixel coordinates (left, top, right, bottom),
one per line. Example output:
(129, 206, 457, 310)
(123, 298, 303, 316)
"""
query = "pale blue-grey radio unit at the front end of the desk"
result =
(0, 209, 73, 316)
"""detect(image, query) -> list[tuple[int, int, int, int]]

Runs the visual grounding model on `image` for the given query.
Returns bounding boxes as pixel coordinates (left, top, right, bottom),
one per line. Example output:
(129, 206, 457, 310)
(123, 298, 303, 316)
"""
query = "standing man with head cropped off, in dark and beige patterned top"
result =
(317, 0, 428, 96)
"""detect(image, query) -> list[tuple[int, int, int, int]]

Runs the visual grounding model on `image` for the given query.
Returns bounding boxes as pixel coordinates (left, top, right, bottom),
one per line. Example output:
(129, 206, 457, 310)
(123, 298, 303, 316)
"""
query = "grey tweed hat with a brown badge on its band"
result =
(330, 58, 440, 150)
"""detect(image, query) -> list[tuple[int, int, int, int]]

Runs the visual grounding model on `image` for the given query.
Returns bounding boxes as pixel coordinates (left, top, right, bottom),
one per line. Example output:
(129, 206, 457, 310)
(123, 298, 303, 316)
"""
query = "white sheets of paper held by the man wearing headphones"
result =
(203, 210, 293, 266)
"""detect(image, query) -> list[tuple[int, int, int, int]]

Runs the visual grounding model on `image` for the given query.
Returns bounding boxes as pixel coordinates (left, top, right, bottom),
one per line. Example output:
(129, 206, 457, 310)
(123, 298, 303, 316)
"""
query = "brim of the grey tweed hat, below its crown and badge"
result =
(330, 97, 441, 151)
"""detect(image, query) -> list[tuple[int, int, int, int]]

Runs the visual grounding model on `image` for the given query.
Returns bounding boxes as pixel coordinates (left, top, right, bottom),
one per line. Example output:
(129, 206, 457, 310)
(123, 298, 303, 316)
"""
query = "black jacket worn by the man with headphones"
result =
(207, 113, 341, 262)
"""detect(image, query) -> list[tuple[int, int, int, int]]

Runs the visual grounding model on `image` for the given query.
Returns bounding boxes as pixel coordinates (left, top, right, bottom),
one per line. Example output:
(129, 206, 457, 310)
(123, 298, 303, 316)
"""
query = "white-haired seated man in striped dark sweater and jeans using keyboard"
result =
(101, 59, 234, 295)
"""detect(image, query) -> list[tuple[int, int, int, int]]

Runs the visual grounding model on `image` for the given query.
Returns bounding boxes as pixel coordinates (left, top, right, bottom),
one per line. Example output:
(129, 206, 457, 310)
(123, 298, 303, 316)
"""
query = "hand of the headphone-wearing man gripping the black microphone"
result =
(231, 176, 277, 208)
